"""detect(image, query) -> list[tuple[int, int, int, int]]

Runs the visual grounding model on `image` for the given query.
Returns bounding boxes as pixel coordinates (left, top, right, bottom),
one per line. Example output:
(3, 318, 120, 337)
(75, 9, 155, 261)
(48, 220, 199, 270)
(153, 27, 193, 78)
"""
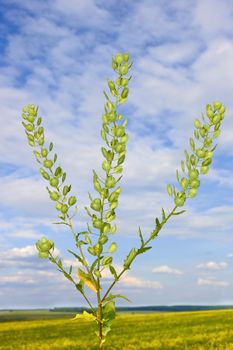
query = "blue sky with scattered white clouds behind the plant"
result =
(0, 0, 233, 308)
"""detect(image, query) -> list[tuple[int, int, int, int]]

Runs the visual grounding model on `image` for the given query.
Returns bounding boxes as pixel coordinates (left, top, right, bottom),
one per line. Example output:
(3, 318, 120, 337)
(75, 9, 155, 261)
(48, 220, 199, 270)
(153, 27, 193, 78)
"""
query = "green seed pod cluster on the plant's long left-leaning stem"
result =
(22, 104, 77, 220)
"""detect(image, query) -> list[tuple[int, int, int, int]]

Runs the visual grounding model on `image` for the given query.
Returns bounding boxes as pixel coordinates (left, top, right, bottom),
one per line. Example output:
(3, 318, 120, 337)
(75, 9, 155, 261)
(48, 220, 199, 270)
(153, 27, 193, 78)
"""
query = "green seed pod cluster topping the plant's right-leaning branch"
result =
(167, 101, 226, 207)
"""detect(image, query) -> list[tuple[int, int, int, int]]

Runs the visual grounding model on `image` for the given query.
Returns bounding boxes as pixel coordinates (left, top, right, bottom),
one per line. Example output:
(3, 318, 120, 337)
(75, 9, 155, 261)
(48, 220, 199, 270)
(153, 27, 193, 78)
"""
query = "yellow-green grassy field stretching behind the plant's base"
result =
(0, 310, 233, 350)
